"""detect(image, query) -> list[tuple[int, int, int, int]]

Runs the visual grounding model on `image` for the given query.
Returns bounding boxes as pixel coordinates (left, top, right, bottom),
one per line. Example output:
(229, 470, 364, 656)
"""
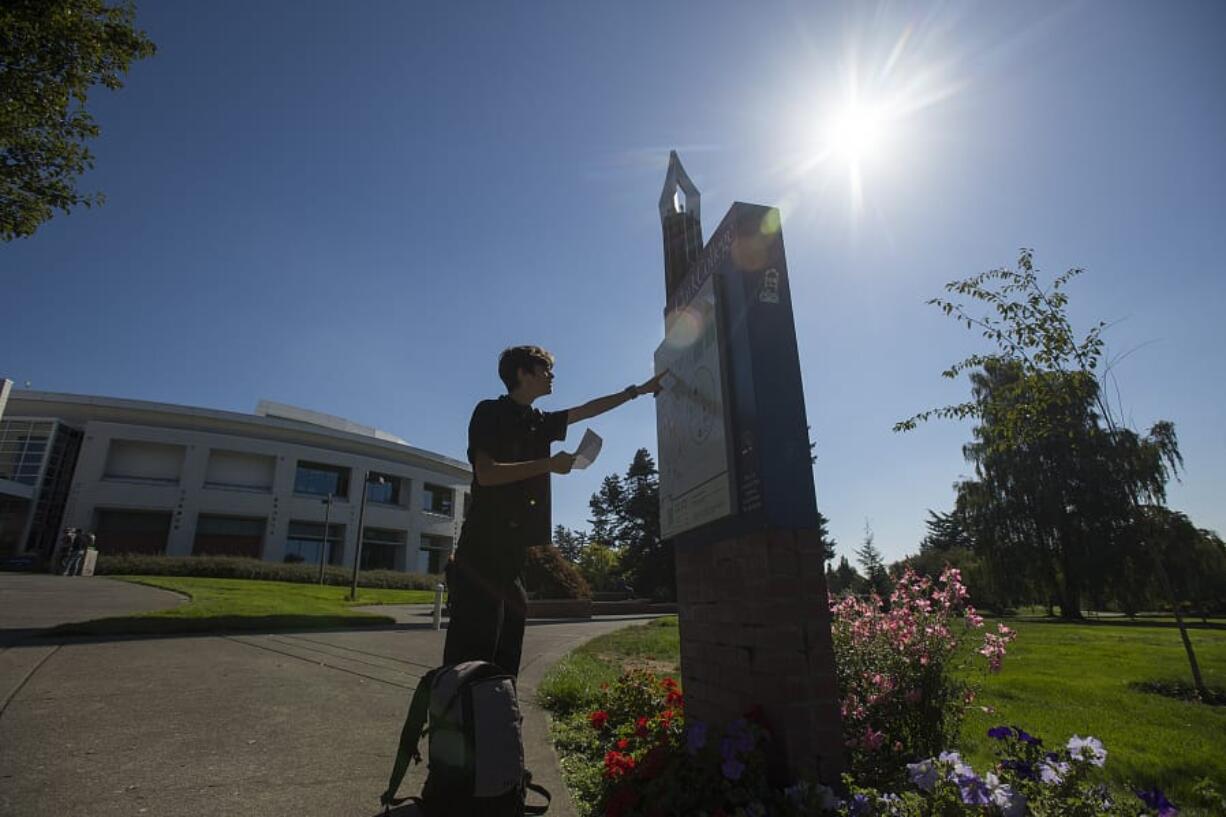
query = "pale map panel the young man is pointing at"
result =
(656, 278, 732, 539)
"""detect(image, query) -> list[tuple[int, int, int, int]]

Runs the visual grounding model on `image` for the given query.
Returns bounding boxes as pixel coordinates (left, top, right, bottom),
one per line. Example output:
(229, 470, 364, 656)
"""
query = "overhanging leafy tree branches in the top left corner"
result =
(0, 0, 157, 242)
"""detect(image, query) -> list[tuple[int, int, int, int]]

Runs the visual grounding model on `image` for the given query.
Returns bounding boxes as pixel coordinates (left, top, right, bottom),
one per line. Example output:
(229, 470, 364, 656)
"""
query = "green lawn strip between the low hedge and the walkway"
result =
(51, 575, 434, 635)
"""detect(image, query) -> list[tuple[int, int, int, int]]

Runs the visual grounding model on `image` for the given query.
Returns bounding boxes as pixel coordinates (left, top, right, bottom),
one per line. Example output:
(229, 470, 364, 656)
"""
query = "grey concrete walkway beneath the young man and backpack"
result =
(0, 574, 644, 817)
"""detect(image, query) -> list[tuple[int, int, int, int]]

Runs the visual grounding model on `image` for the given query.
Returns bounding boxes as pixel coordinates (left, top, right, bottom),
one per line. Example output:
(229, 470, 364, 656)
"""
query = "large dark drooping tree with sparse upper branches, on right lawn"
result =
(894, 249, 1206, 696)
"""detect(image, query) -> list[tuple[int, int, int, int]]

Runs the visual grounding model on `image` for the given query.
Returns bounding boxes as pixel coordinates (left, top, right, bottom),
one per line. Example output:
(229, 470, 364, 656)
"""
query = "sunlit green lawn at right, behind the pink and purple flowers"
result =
(961, 619, 1226, 802)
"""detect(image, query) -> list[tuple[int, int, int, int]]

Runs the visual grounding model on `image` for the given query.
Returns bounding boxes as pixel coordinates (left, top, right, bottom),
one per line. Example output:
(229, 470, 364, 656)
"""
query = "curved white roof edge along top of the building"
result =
(5, 389, 472, 478)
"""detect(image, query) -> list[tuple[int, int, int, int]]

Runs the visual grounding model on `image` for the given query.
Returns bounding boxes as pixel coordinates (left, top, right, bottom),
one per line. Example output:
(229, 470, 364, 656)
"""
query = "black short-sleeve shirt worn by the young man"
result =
(456, 395, 566, 581)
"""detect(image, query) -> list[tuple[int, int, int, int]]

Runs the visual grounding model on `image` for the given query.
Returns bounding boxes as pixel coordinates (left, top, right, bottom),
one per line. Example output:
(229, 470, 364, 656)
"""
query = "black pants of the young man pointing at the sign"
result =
(443, 563, 528, 676)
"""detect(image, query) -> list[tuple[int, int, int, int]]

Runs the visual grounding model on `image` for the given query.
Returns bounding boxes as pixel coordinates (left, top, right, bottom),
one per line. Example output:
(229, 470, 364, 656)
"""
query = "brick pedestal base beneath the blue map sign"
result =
(677, 530, 843, 783)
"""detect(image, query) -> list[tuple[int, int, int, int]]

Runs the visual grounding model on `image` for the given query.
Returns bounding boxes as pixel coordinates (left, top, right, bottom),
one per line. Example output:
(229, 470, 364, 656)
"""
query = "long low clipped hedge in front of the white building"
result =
(94, 553, 441, 590)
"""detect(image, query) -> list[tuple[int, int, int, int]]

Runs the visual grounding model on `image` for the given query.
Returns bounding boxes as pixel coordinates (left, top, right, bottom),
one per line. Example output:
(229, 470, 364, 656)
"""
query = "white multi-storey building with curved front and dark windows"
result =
(0, 382, 472, 573)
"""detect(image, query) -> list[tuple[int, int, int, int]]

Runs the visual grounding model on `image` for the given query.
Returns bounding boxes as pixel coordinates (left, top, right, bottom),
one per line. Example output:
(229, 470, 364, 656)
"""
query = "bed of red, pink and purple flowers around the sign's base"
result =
(541, 570, 1211, 817)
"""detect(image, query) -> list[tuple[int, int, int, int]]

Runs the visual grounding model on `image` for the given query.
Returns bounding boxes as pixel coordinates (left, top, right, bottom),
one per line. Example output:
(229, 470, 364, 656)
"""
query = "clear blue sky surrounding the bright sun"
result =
(0, 0, 1226, 558)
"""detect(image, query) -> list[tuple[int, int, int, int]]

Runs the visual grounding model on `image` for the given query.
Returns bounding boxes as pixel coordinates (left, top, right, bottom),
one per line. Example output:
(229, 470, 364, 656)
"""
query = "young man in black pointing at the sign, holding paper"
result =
(443, 346, 663, 676)
